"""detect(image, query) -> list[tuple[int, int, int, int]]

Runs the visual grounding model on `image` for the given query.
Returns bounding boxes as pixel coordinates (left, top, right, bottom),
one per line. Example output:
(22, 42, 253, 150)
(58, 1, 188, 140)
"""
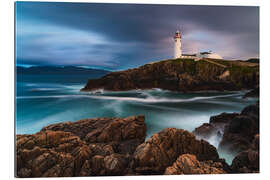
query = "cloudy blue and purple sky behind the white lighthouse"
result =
(15, 2, 259, 71)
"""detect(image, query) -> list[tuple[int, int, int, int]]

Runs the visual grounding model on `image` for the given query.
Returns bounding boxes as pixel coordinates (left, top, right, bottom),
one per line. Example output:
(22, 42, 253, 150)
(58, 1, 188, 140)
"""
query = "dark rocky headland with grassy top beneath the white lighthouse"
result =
(82, 59, 259, 92)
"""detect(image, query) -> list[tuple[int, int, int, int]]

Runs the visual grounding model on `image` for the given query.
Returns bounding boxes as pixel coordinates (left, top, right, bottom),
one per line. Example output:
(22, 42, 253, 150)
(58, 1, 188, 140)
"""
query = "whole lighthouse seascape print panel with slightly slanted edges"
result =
(15, 2, 259, 177)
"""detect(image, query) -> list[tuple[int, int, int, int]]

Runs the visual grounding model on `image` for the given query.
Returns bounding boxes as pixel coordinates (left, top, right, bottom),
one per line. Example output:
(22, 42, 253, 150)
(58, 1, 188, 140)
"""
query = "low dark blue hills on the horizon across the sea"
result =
(17, 66, 110, 75)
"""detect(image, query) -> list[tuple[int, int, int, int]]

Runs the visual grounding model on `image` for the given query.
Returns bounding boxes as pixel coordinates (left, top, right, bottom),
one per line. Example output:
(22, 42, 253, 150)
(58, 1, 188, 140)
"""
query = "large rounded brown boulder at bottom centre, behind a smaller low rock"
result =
(133, 128, 219, 174)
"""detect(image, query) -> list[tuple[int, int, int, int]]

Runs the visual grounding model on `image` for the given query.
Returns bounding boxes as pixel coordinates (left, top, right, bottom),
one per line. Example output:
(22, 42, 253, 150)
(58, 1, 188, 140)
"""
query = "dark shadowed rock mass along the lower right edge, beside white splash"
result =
(194, 103, 260, 173)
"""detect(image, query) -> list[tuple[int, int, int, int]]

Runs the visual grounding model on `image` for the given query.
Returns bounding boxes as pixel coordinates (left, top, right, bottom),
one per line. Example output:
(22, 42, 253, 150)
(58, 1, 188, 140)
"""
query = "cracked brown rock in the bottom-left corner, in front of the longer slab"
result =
(16, 131, 85, 177)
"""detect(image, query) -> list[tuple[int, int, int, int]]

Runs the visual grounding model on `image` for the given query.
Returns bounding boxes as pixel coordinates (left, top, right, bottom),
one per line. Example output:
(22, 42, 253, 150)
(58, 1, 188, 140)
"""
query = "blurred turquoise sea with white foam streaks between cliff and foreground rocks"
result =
(15, 74, 258, 164)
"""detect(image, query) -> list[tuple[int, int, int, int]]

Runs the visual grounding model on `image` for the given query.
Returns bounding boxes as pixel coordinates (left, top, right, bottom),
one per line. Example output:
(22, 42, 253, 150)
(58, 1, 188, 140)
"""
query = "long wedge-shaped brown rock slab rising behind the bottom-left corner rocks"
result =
(41, 116, 146, 153)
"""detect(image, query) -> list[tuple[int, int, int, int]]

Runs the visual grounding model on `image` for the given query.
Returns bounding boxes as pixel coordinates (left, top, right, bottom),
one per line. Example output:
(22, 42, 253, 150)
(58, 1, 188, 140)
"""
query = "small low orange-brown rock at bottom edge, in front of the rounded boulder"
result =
(164, 154, 226, 175)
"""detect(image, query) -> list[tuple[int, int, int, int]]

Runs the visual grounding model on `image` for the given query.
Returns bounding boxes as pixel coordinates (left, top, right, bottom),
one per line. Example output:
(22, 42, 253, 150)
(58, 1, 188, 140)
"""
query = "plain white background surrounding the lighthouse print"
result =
(0, 0, 270, 180)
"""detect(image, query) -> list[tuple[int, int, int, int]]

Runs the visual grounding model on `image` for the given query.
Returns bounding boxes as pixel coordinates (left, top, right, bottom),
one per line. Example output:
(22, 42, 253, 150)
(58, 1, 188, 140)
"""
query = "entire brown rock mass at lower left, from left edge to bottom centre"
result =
(16, 116, 146, 177)
